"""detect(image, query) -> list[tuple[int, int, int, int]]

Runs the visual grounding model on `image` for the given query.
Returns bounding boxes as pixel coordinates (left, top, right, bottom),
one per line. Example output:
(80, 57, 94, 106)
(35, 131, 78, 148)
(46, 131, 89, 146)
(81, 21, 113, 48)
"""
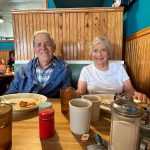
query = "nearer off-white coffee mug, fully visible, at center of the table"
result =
(69, 98, 92, 135)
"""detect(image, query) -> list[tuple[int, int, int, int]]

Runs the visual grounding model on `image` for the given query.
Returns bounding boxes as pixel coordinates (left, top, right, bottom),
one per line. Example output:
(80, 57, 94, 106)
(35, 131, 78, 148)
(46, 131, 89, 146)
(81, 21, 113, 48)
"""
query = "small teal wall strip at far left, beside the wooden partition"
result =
(0, 42, 15, 50)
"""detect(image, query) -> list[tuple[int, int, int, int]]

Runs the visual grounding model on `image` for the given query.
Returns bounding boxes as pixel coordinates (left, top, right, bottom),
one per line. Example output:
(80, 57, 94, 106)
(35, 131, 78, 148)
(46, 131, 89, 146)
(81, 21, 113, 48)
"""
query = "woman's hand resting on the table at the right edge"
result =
(133, 92, 150, 104)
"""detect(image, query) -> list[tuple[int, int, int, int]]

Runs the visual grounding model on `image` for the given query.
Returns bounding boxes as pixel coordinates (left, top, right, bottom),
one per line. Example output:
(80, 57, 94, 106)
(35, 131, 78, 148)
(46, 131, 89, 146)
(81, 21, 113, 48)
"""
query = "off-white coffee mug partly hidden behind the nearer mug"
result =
(82, 95, 101, 122)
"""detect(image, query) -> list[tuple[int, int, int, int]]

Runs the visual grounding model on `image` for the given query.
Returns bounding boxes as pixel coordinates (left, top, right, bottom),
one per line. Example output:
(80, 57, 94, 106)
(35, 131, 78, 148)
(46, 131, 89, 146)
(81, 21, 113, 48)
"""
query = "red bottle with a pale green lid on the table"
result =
(39, 102, 55, 139)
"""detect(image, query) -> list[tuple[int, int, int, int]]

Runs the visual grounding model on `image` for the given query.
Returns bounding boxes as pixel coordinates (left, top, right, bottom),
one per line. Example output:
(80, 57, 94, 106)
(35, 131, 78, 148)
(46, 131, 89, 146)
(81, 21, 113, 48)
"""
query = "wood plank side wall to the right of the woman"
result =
(125, 27, 150, 97)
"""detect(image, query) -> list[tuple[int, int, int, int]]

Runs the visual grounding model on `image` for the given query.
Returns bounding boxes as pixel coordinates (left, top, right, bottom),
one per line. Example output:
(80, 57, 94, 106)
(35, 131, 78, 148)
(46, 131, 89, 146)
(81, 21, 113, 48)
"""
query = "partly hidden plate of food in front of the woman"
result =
(95, 94, 114, 113)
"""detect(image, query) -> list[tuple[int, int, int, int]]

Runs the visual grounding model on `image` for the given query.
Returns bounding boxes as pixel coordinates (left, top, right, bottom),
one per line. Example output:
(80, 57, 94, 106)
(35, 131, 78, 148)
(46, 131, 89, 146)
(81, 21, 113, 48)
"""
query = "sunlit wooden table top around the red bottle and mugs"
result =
(12, 99, 110, 150)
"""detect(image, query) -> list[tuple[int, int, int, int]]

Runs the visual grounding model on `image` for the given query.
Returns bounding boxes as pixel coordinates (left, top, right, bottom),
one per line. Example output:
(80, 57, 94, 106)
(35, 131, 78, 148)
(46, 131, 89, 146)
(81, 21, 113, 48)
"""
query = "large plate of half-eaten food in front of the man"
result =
(0, 93, 47, 113)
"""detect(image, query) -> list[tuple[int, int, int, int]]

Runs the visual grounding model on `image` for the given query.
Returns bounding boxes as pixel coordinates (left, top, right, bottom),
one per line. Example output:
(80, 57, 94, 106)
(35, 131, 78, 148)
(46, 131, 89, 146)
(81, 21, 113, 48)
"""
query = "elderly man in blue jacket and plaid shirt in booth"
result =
(7, 30, 71, 97)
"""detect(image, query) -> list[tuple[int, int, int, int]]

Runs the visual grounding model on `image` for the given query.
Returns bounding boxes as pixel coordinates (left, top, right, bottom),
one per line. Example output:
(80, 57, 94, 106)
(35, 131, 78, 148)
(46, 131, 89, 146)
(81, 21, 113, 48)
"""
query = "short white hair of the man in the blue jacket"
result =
(32, 30, 56, 50)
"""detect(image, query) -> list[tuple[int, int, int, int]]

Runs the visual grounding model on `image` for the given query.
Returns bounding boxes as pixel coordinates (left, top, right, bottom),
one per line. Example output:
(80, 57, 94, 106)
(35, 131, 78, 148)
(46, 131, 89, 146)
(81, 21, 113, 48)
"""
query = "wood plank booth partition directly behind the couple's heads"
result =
(12, 7, 123, 60)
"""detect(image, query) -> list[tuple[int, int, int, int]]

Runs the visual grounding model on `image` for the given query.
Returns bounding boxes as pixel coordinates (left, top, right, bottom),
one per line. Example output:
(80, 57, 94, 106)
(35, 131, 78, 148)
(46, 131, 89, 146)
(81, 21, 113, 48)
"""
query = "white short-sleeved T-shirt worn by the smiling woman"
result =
(79, 63, 129, 94)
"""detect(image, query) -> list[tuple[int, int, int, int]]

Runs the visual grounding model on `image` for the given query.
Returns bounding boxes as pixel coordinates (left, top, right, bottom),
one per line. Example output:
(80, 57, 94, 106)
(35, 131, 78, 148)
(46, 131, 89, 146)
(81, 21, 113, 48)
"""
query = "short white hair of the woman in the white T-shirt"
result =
(89, 36, 112, 56)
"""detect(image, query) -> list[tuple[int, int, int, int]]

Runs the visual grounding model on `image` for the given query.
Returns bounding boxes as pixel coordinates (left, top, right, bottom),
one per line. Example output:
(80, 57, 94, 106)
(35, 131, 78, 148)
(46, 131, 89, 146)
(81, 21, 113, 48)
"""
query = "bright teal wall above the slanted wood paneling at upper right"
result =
(124, 0, 150, 37)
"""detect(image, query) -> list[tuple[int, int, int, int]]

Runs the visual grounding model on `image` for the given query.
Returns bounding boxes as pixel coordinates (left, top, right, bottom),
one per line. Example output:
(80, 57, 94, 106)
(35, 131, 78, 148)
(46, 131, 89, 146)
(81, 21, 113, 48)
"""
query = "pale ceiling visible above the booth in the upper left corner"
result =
(0, 0, 46, 37)
